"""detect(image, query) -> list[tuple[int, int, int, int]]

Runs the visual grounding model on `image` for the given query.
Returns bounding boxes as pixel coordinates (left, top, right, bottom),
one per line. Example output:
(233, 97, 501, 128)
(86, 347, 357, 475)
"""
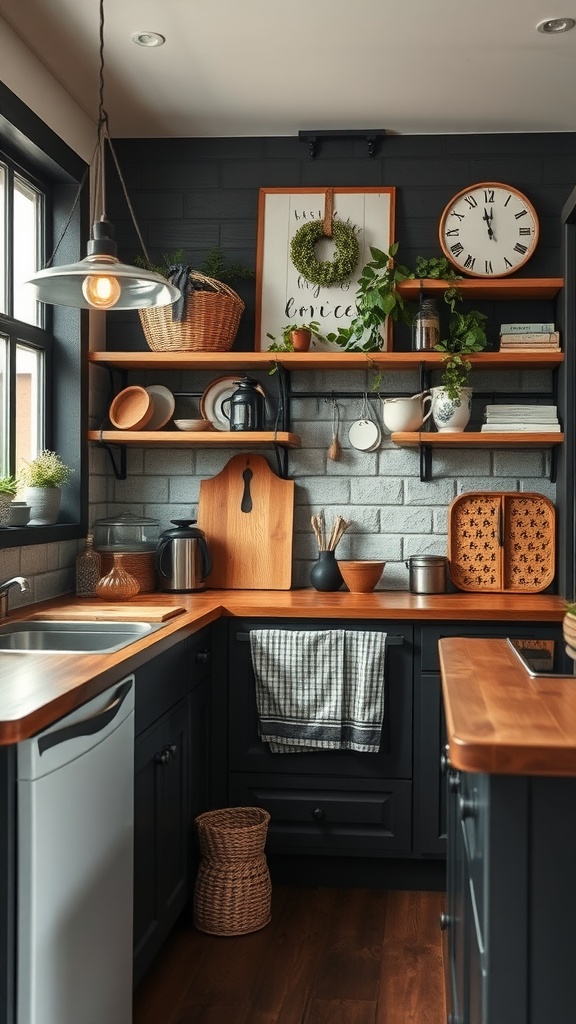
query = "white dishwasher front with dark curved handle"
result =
(16, 676, 134, 1024)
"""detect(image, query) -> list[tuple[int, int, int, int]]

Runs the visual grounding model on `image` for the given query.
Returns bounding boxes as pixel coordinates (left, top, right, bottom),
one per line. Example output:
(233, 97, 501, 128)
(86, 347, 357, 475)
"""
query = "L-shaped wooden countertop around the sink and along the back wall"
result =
(0, 590, 565, 745)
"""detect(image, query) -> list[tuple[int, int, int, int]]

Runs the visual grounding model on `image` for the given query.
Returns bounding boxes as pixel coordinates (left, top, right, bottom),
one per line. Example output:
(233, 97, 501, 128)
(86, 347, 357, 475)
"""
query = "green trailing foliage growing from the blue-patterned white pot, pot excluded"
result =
(435, 287, 487, 399)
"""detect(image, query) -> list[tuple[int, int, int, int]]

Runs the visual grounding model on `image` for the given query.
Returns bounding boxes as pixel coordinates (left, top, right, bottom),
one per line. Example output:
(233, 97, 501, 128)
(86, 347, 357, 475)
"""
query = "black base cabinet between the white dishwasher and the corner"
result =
(134, 631, 210, 984)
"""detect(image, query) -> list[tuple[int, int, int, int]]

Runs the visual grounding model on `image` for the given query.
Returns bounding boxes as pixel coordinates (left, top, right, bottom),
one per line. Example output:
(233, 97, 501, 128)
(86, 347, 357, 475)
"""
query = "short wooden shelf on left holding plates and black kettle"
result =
(88, 430, 301, 449)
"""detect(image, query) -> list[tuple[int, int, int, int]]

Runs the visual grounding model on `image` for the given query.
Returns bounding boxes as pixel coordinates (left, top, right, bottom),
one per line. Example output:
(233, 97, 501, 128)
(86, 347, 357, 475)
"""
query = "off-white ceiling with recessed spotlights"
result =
(0, 0, 576, 137)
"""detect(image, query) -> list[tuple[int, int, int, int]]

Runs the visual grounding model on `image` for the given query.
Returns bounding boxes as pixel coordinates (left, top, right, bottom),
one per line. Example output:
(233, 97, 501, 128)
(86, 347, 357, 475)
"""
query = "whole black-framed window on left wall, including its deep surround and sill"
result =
(0, 82, 89, 549)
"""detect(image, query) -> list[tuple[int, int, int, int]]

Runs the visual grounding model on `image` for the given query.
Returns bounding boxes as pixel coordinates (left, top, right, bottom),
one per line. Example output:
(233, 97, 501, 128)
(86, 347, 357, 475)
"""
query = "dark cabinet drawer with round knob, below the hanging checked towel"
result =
(230, 772, 412, 856)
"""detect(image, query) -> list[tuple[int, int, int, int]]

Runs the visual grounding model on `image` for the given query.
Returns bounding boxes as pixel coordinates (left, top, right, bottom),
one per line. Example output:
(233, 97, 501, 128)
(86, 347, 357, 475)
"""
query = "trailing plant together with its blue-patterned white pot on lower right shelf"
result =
(430, 287, 487, 432)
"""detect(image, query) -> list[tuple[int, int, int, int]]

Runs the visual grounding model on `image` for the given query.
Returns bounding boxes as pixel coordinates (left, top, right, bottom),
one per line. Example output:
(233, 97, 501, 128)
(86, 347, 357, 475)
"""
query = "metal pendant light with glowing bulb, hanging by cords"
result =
(27, 0, 180, 309)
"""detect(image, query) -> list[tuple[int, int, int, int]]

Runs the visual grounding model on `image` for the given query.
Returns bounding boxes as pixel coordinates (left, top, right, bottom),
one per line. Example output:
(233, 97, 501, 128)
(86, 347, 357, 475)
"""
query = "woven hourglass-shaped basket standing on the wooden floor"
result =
(194, 807, 272, 935)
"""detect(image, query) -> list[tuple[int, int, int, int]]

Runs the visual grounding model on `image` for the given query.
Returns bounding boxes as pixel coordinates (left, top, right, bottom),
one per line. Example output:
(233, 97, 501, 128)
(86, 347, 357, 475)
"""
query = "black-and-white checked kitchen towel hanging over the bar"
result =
(250, 629, 386, 754)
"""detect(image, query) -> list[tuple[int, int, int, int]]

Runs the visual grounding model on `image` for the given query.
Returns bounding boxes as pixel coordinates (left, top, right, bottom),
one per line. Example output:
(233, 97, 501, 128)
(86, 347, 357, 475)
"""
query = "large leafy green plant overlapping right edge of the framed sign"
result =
(326, 242, 414, 352)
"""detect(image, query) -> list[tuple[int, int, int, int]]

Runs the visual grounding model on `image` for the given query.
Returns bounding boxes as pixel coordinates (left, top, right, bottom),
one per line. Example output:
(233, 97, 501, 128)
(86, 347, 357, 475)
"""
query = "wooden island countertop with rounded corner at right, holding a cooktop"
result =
(439, 637, 576, 776)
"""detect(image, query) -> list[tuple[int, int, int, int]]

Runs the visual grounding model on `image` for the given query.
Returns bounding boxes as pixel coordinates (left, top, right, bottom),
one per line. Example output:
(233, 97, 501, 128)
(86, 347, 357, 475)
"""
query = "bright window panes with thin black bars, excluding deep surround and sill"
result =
(0, 154, 52, 475)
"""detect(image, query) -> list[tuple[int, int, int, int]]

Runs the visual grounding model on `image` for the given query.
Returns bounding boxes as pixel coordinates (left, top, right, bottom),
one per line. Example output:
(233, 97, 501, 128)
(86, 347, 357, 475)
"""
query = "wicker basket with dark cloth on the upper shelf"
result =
(138, 270, 244, 352)
